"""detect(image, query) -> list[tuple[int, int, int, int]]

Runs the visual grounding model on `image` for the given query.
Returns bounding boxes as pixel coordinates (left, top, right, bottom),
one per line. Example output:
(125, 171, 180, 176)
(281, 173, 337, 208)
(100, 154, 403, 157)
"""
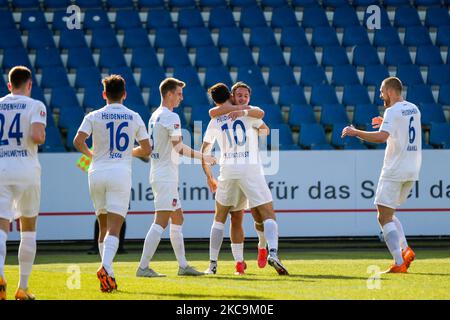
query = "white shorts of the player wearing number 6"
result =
(374, 179, 414, 209)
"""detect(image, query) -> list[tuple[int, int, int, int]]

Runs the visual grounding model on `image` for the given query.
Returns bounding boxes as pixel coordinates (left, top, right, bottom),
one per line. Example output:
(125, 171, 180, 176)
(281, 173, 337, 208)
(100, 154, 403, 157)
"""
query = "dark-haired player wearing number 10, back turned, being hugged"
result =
(203, 84, 288, 275)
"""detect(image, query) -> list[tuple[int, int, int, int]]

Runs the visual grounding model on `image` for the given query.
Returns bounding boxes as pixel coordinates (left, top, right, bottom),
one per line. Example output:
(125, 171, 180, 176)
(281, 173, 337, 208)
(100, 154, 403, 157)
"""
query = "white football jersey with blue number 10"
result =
(203, 115, 264, 180)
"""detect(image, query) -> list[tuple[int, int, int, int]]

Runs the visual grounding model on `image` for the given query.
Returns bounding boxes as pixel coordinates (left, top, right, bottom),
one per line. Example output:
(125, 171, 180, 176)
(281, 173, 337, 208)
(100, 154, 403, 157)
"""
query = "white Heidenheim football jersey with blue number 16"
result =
(78, 103, 148, 172)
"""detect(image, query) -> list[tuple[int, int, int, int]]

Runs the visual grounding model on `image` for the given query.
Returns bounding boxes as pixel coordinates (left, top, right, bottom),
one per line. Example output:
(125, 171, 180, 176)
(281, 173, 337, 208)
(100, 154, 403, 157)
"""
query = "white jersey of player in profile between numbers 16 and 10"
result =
(148, 106, 181, 183)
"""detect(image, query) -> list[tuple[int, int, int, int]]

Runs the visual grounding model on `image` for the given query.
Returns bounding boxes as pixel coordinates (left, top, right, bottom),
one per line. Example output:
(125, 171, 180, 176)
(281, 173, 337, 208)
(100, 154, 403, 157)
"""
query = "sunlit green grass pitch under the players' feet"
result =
(0, 247, 450, 300)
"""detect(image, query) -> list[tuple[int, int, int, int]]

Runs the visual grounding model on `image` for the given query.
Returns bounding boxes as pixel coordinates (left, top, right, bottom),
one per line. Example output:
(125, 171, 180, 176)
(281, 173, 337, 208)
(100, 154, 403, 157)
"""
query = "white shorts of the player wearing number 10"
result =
(216, 174, 272, 208)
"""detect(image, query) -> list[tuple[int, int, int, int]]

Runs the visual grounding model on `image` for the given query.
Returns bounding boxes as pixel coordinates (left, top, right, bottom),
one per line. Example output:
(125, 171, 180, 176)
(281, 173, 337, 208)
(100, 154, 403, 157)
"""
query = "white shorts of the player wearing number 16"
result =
(88, 170, 131, 218)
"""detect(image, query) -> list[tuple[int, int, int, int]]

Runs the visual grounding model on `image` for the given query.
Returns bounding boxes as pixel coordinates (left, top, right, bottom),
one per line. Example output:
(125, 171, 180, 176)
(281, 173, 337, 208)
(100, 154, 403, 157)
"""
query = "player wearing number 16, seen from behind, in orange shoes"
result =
(74, 75, 151, 292)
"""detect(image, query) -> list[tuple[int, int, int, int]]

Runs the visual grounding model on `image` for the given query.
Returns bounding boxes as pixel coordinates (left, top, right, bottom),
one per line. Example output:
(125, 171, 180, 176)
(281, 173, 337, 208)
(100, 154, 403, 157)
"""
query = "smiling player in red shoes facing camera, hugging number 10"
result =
(202, 82, 268, 275)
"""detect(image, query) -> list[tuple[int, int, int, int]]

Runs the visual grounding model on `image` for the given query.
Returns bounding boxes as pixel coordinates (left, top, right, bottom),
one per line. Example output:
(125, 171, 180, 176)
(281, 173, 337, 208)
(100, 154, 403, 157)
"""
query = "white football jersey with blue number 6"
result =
(380, 101, 422, 181)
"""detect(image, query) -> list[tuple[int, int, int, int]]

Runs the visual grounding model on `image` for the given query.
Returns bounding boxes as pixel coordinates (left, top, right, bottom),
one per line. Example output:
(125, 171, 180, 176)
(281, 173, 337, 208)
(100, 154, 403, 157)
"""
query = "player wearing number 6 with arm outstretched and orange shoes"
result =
(342, 77, 422, 273)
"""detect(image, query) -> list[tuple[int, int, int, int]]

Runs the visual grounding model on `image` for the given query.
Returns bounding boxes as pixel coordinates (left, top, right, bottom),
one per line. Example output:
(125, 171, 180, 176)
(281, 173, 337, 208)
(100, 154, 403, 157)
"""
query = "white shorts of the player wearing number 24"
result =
(0, 184, 41, 221)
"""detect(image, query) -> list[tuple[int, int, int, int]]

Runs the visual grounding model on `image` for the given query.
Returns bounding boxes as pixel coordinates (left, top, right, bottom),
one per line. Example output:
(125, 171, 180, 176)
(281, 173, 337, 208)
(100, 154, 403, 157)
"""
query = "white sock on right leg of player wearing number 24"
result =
(19, 232, 36, 289)
